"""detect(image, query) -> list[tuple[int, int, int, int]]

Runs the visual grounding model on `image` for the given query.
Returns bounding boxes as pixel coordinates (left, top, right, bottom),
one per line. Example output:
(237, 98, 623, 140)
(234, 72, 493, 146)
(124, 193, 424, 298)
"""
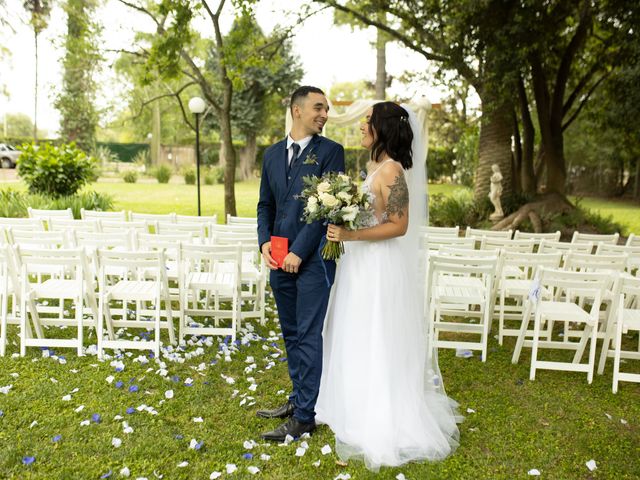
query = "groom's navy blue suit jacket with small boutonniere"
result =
(258, 135, 344, 262)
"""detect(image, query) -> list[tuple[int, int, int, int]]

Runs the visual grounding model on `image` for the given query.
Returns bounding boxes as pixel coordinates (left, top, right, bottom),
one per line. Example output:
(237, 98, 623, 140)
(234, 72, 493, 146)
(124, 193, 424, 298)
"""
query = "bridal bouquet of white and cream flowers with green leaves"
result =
(298, 172, 373, 260)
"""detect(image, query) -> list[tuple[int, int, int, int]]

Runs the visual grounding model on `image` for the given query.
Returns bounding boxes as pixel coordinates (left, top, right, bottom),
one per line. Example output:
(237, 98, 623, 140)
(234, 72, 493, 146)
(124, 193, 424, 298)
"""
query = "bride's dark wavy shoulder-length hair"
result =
(369, 102, 413, 170)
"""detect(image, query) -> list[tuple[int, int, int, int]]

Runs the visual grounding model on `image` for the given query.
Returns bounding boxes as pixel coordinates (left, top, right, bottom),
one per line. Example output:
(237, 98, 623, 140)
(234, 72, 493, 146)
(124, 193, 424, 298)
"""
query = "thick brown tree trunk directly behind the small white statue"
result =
(473, 101, 513, 202)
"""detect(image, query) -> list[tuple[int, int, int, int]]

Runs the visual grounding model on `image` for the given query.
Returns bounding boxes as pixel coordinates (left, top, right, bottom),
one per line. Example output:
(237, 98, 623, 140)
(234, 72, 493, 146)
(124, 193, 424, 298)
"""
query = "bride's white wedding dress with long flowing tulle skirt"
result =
(316, 158, 461, 470)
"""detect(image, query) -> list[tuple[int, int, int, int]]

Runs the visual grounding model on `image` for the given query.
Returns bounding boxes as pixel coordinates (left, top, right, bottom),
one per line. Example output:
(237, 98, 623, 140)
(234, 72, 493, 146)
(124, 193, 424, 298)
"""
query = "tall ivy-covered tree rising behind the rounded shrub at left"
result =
(55, 0, 101, 152)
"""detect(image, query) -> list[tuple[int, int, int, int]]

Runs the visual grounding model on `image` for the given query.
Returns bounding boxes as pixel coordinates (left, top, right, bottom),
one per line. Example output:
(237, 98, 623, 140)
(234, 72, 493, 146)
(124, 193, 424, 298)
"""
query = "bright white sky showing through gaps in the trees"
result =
(0, 0, 442, 136)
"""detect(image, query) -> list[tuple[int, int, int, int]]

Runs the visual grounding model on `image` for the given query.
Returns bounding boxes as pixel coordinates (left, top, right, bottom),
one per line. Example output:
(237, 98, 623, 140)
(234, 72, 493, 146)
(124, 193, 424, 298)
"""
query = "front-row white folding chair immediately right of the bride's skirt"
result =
(428, 254, 498, 362)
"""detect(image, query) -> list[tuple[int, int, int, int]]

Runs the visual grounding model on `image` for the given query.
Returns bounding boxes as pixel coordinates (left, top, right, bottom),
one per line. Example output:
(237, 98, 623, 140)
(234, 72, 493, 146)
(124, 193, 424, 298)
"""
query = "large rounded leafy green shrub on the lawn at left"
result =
(18, 143, 97, 197)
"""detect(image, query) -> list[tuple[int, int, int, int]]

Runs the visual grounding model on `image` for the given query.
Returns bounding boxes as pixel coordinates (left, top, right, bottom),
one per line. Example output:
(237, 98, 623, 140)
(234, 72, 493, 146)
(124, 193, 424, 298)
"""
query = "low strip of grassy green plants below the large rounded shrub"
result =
(0, 188, 113, 218)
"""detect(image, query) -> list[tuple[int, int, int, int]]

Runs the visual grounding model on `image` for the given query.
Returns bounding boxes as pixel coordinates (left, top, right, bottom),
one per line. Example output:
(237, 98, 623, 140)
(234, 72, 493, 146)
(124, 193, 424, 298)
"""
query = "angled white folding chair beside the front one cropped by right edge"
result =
(518, 267, 607, 383)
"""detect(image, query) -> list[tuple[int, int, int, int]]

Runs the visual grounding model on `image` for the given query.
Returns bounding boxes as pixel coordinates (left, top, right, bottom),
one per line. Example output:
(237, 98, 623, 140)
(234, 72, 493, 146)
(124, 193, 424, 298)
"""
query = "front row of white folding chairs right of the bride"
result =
(426, 245, 640, 392)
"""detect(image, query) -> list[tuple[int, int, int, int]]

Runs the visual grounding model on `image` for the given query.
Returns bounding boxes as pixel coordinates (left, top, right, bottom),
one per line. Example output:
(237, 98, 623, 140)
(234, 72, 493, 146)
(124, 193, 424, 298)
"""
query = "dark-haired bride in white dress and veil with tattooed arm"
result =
(316, 102, 461, 471)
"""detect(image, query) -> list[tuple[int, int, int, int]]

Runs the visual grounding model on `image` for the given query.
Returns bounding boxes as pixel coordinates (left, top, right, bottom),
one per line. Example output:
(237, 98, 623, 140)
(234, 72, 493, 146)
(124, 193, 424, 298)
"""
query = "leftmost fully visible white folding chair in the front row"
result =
(16, 247, 98, 356)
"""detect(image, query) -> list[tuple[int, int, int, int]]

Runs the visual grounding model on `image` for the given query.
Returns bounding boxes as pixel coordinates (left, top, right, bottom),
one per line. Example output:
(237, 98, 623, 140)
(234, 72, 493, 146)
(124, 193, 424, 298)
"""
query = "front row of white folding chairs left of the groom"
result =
(0, 243, 262, 356)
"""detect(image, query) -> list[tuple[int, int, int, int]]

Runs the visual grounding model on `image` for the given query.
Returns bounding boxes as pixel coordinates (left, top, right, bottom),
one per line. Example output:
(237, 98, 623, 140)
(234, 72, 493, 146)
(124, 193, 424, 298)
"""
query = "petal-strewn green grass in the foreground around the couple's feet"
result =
(0, 292, 640, 480)
